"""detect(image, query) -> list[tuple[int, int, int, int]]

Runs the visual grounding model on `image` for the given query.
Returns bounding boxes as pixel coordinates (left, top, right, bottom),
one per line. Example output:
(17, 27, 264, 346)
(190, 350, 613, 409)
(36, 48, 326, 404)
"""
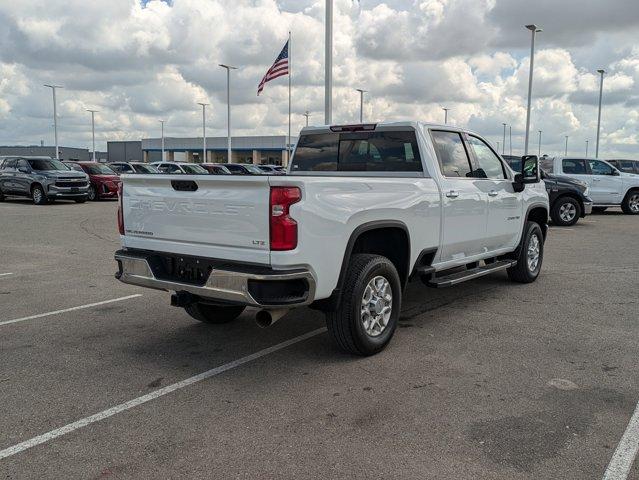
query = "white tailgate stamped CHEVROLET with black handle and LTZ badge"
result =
(122, 175, 270, 264)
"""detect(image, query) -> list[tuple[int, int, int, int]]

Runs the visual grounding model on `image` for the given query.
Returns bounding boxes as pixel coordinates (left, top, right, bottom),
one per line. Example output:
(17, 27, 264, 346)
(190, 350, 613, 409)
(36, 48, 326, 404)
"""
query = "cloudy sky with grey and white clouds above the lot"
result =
(0, 0, 639, 158)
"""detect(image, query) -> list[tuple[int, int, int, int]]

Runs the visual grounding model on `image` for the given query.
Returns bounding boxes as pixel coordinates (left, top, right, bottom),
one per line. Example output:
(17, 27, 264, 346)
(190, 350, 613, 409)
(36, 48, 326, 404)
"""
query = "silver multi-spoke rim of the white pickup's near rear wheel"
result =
(360, 275, 393, 337)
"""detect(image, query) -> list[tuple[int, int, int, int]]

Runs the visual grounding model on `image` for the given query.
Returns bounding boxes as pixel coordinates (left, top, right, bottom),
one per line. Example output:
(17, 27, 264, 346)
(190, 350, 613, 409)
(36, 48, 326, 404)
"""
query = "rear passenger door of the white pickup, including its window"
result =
(430, 130, 488, 264)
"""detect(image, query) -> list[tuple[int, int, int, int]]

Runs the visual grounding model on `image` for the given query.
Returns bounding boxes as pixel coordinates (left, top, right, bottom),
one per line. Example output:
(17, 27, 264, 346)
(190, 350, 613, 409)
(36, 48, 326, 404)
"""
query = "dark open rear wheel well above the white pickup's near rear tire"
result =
(351, 227, 410, 286)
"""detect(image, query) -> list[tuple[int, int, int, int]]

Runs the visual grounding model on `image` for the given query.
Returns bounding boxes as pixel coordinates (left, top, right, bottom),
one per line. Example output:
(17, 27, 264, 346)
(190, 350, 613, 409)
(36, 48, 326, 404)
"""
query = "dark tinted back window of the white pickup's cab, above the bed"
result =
(291, 130, 423, 172)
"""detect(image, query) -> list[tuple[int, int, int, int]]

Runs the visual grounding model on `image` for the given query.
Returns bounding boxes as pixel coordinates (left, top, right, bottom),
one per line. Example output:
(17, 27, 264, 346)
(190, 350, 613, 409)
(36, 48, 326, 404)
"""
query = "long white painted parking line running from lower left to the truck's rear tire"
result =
(0, 327, 326, 460)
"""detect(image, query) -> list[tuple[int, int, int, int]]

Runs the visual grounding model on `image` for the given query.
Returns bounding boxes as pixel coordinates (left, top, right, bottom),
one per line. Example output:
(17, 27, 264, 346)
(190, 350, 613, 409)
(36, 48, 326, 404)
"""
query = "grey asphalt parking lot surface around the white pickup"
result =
(0, 200, 639, 479)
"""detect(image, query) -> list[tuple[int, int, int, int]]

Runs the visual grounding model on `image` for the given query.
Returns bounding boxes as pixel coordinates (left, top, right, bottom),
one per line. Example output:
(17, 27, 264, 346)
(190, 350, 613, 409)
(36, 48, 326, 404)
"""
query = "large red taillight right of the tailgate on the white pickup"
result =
(270, 187, 302, 250)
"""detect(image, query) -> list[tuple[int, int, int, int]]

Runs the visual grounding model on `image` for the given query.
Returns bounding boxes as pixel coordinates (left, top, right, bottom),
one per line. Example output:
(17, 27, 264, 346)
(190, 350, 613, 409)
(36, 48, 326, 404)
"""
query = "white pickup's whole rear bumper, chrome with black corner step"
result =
(115, 250, 315, 309)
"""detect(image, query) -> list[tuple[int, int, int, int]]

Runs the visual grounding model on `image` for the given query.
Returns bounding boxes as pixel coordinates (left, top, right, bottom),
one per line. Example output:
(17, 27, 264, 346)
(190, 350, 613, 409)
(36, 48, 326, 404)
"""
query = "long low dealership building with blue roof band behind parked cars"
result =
(138, 135, 297, 165)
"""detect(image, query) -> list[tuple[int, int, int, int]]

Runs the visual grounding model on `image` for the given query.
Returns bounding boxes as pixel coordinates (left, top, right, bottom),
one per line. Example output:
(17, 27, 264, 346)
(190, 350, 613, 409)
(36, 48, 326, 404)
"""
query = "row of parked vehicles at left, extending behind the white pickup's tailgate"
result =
(0, 156, 285, 205)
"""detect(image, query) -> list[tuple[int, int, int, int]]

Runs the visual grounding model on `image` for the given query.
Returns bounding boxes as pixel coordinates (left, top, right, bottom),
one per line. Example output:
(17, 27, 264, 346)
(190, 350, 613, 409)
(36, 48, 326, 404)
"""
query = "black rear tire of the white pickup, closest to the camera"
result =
(326, 254, 402, 355)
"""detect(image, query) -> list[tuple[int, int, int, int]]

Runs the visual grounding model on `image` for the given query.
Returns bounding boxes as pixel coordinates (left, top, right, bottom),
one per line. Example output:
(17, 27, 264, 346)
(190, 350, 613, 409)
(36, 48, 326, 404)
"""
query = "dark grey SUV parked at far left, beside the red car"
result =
(0, 157, 89, 205)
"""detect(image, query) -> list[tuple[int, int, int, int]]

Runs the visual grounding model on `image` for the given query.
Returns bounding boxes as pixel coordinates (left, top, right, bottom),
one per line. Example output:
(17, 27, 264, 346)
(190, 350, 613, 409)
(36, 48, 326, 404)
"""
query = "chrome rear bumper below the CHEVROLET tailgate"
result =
(115, 251, 315, 309)
